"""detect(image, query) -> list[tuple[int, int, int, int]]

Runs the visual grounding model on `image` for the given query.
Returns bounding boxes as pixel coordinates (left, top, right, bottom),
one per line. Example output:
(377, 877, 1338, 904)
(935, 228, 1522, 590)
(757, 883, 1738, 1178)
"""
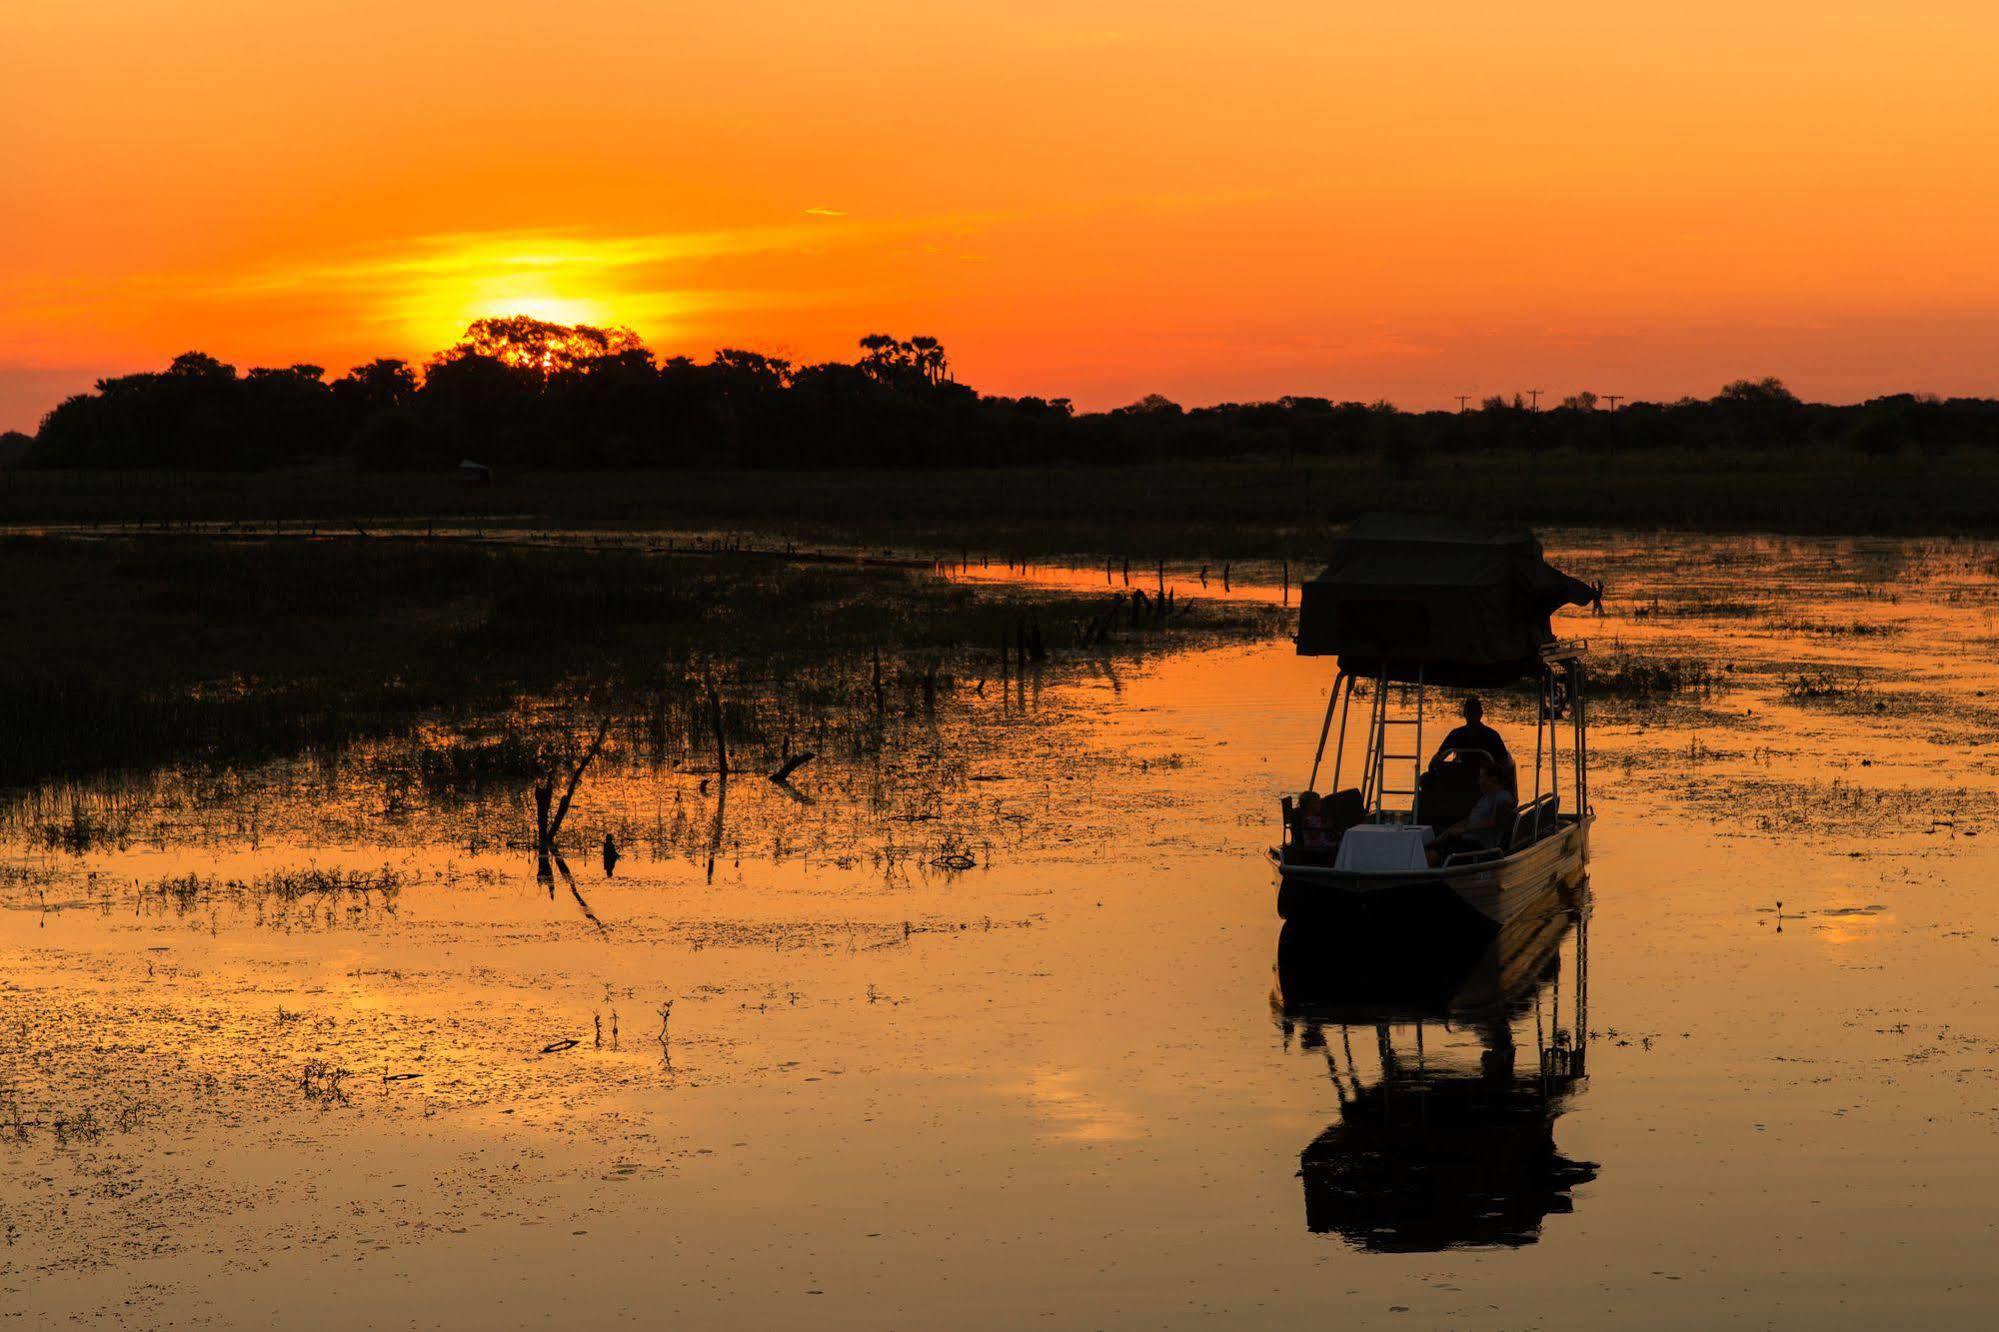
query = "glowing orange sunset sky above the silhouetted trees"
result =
(0, 0, 1999, 428)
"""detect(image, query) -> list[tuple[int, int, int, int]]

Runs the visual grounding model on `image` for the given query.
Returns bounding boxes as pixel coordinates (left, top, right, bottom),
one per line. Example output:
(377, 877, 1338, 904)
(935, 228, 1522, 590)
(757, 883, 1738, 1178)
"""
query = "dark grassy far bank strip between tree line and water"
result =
(0, 452, 1999, 564)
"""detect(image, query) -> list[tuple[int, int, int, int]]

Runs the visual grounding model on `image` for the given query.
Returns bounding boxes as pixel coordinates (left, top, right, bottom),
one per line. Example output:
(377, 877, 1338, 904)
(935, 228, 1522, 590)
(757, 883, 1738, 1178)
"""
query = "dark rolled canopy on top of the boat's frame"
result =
(1297, 514, 1595, 684)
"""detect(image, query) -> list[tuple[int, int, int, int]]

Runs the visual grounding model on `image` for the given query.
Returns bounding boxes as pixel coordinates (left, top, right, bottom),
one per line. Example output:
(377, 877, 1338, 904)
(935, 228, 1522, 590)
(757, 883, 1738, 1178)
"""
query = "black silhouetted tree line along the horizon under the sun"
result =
(16, 316, 1999, 470)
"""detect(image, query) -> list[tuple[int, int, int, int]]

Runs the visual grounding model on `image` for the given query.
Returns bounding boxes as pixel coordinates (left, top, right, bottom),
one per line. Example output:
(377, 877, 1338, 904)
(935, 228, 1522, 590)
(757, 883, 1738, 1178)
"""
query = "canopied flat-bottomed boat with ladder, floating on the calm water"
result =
(1269, 516, 1601, 928)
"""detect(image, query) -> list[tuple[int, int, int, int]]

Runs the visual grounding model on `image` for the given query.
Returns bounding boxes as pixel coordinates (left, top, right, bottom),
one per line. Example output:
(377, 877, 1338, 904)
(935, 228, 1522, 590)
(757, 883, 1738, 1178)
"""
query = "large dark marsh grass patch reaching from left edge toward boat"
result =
(0, 536, 1281, 792)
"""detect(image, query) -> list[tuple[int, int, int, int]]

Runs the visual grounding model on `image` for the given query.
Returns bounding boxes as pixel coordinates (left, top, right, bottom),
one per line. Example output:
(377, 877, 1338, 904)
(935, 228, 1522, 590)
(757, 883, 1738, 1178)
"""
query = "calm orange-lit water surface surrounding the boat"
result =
(0, 534, 1999, 1328)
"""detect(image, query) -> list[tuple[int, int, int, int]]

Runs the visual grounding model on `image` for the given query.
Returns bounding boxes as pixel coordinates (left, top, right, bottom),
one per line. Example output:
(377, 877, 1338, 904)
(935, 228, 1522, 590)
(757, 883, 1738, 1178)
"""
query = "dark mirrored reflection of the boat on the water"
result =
(1271, 882, 1597, 1252)
